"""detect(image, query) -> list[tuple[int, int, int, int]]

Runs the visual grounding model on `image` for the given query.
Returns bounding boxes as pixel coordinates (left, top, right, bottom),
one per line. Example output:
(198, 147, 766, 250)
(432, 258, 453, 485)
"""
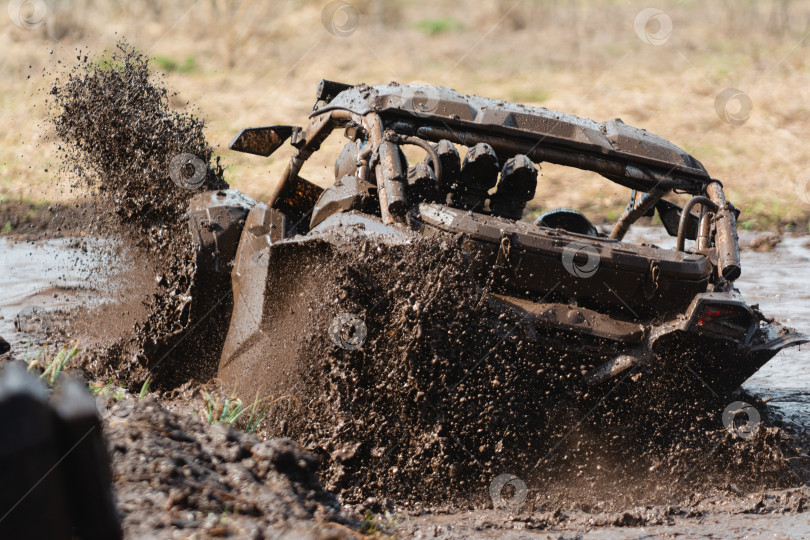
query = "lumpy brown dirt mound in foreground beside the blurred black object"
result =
(104, 398, 349, 538)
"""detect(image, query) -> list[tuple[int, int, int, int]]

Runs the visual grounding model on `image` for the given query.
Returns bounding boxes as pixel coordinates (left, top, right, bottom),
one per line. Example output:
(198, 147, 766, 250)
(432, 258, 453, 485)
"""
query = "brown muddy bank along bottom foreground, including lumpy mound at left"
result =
(85, 372, 810, 538)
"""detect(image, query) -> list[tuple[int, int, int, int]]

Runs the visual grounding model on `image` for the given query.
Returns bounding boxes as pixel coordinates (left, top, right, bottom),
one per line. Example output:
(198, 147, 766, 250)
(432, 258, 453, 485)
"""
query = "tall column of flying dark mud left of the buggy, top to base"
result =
(51, 43, 227, 386)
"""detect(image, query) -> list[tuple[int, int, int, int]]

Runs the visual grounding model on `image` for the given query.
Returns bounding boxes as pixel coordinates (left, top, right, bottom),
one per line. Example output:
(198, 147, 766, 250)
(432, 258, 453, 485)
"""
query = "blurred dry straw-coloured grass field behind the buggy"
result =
(0, 0, 810, 231)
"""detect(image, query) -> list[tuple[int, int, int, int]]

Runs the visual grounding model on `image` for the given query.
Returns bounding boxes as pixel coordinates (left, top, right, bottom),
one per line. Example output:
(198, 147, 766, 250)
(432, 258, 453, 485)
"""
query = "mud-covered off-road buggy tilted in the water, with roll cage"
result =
(186, 81, 807, 408)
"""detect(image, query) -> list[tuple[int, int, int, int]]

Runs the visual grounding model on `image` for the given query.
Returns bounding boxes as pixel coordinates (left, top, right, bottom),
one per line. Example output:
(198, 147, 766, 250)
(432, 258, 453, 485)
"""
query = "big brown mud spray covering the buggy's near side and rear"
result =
(241, 233, 807, 511)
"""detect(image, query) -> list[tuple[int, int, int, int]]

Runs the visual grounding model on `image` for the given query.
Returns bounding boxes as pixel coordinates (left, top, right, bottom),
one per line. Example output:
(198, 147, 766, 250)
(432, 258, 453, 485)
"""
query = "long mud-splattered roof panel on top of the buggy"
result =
(313, 83, 709, 180)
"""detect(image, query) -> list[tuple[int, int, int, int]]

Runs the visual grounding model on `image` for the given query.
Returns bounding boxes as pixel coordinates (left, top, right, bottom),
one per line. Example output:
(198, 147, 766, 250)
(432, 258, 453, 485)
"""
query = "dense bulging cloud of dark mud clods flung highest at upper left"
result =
(51, 40, 228, 231)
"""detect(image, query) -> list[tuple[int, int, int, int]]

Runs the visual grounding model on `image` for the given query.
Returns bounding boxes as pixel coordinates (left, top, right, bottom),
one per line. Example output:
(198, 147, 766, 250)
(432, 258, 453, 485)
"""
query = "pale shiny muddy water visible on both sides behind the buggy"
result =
(0, 227, 810, 410)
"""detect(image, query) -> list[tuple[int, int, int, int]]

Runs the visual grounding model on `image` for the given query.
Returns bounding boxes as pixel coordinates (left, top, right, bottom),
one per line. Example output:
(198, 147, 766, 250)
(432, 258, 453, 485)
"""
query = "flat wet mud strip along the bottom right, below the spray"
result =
(396, 485, 810, 540)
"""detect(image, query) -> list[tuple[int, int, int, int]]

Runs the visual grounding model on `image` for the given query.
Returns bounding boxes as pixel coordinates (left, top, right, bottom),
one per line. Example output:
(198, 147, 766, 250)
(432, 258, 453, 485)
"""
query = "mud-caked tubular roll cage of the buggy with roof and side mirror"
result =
(230, 80, 741, 281)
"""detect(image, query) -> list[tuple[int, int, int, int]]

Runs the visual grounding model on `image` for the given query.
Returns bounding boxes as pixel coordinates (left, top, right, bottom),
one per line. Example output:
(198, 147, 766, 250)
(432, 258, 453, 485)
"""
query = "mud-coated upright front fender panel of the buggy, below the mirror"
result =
(219, 204, 331, 397)
